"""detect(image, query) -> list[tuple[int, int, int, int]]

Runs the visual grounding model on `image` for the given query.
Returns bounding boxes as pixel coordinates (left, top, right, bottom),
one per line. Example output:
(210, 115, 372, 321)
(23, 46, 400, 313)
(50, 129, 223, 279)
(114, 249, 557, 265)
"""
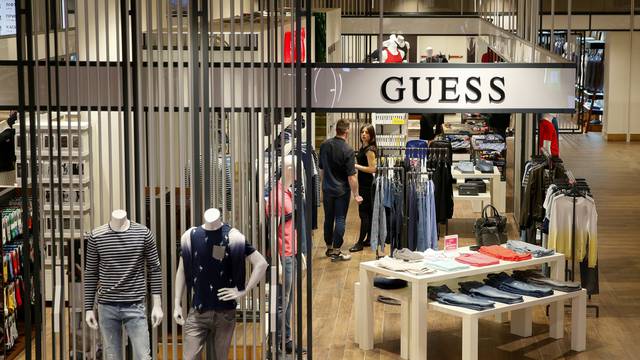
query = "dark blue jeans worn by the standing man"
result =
(322, 191, 351, 249)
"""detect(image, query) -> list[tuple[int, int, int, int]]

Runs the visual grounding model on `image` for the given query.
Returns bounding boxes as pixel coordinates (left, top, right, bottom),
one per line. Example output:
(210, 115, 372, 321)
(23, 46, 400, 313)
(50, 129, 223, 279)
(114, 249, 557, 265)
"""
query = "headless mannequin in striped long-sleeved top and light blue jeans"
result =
(84, 210, 164, 359)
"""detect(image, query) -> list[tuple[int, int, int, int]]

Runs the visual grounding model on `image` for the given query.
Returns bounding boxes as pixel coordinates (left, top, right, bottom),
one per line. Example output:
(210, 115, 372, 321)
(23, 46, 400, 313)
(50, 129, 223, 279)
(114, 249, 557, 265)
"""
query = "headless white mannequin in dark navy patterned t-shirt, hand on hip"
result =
(173, 208, 268, 360)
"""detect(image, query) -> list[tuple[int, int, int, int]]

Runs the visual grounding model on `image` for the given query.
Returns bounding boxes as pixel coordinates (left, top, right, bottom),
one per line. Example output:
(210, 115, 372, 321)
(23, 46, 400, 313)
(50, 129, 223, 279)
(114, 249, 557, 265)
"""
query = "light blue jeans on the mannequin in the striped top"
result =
(98, 302, 151, 360)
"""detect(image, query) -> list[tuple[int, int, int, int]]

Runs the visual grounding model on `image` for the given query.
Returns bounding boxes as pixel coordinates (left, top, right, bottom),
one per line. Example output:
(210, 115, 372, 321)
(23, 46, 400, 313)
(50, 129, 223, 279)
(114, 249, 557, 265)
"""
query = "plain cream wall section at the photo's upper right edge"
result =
(604, 31, 640, 141)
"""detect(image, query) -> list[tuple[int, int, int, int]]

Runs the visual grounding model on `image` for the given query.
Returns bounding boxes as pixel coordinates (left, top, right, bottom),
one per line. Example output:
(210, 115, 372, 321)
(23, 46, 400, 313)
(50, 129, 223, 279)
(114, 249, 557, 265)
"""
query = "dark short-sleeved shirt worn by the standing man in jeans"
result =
(320, 137, 356, 197)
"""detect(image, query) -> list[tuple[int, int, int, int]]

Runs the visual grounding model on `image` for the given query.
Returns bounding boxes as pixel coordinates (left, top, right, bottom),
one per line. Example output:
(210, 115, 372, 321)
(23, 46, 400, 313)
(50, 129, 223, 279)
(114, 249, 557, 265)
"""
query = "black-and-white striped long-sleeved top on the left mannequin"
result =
(84, 221, 162, 311)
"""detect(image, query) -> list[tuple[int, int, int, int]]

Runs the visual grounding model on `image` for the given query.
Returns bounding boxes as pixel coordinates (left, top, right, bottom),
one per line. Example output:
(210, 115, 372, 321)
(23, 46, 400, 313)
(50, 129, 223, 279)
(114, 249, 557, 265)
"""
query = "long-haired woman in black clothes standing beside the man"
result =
(349, 125, 378, 252)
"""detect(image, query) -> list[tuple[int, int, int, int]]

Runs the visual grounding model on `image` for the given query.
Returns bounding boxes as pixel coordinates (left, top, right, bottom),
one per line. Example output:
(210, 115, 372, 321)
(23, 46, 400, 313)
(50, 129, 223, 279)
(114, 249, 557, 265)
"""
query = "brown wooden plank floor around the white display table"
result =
(313, 134, 640, 360)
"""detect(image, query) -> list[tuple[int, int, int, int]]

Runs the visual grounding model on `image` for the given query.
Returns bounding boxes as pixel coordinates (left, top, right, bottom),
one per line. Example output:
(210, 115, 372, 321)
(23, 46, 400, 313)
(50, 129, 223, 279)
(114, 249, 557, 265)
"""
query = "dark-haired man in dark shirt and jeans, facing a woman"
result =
(320, 119, 362, 261)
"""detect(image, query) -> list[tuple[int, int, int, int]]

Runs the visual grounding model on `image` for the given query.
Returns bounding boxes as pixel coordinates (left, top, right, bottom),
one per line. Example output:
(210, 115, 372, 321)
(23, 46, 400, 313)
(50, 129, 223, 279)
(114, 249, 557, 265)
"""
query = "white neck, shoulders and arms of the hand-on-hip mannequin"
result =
(173, 208, 268, 325)
